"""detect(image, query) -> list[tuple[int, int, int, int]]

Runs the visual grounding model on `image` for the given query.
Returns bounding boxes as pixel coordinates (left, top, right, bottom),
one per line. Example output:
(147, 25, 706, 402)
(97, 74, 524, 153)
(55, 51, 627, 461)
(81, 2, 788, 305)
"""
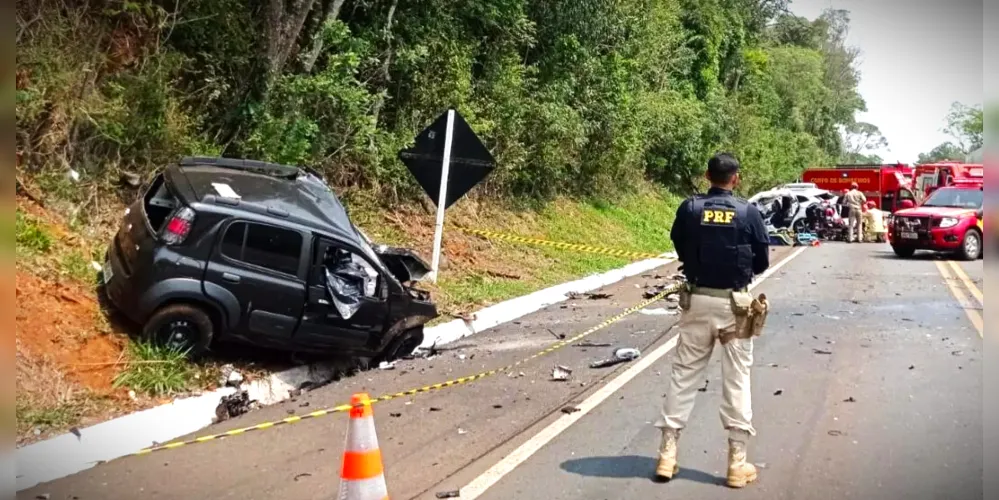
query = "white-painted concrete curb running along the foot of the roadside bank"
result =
(15, 254, 676, 491)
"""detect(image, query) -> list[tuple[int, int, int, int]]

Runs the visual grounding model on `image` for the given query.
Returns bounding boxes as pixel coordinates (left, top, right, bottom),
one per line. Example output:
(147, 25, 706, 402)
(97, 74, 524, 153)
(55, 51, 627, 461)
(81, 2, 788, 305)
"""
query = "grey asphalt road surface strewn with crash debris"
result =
(18, 244, 984, 499)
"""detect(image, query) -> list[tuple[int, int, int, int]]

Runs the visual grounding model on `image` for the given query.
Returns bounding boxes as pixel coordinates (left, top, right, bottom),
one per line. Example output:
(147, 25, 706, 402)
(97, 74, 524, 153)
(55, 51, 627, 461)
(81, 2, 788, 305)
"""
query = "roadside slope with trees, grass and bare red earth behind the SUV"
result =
(14, 0, 883, 443)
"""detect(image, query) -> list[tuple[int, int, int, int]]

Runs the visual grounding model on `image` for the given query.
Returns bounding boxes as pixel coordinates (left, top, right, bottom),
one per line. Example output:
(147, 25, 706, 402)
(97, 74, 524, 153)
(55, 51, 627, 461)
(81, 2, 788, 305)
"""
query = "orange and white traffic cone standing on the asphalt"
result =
(337, 393, 388, 500)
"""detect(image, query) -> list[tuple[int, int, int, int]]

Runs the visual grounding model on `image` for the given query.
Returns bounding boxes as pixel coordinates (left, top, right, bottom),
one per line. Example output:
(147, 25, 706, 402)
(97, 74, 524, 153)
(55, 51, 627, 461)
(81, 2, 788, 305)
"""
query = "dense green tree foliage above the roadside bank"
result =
(16, 0, 876, 201)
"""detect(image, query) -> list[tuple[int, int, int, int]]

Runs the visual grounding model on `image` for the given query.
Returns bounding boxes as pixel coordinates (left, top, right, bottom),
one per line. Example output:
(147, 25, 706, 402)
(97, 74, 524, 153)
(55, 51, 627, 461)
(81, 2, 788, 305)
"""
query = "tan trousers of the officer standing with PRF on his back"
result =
(656, 294, 756, 436)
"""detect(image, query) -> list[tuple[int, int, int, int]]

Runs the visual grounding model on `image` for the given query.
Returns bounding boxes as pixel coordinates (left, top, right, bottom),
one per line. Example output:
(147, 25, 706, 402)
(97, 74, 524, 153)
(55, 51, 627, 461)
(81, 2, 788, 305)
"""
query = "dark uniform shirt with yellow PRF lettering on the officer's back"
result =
(670, 187, 770, 289)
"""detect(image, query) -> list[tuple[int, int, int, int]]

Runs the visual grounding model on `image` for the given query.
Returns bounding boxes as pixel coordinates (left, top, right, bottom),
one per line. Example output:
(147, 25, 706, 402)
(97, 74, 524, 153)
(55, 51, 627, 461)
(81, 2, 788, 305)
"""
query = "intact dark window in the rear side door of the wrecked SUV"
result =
(222, 222, 302, 275)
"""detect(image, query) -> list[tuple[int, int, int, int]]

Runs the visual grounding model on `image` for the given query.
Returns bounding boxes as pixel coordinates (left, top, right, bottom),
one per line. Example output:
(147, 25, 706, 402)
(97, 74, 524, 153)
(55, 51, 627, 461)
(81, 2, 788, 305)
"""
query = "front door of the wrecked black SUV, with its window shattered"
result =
(296, 238, 389, 353)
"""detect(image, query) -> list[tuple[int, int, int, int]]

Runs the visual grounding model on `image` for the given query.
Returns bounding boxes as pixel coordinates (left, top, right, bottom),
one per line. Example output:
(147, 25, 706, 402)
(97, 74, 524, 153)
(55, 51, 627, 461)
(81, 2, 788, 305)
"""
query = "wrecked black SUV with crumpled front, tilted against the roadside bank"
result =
(103, 158, 437, 359)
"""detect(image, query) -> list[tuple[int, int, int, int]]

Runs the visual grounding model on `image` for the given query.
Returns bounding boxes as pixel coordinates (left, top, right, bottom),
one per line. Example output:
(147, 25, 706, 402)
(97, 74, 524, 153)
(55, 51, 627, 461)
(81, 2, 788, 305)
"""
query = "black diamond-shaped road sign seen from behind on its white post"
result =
(399, 109, 496, 283)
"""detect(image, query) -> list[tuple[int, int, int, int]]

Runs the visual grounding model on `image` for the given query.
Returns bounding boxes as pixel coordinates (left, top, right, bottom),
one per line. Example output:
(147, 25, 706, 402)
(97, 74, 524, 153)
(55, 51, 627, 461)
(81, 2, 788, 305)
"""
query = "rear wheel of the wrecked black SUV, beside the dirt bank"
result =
(142, 304, 215, 358)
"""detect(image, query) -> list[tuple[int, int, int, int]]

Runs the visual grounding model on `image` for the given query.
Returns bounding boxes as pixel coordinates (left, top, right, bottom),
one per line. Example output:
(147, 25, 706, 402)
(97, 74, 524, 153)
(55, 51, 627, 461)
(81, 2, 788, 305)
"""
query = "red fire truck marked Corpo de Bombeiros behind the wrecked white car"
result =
(802, 163, 915, 213)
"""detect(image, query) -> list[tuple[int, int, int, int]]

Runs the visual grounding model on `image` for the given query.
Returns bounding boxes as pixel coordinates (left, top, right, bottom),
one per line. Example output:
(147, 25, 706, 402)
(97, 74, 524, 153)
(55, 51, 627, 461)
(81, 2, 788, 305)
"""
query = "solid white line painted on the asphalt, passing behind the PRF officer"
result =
(460, 247, 808, 500)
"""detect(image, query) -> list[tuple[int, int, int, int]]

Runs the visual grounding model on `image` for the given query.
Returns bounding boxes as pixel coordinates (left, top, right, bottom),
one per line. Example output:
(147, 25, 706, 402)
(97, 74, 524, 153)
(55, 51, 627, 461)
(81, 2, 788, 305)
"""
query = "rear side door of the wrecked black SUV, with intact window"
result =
(205, 220, 305, 346)
